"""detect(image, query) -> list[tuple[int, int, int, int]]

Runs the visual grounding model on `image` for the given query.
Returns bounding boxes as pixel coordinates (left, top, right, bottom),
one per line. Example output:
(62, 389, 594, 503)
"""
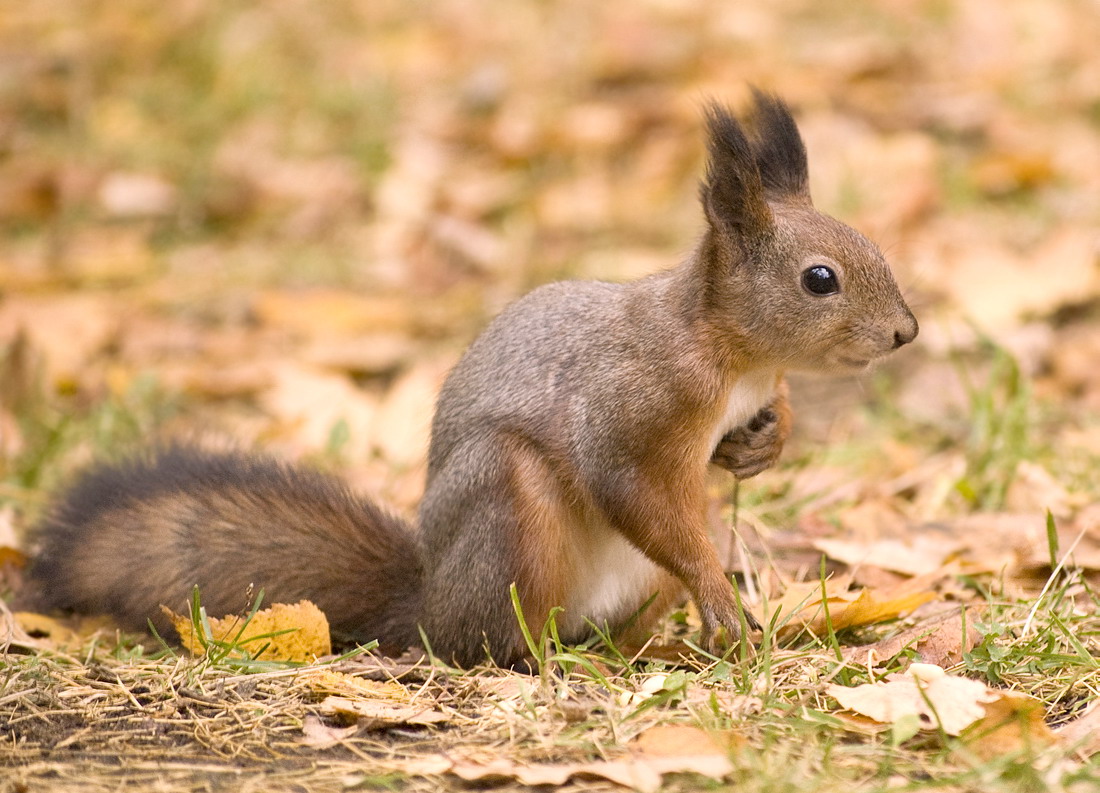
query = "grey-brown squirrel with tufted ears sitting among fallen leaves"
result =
(31, 89, 917, 667)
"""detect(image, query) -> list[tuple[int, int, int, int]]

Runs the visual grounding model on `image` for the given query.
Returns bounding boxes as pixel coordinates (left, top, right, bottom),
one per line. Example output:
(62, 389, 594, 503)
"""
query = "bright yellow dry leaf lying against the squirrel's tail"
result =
(161, 601, 332, 663)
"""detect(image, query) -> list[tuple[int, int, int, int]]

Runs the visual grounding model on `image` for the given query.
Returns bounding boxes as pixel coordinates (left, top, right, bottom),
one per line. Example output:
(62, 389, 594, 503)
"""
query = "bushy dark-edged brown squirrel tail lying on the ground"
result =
(30, 444, 422, 653)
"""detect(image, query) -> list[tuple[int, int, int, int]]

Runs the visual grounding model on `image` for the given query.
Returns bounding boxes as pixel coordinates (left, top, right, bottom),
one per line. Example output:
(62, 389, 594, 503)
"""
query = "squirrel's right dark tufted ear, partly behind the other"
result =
(748, 87, 810, 201)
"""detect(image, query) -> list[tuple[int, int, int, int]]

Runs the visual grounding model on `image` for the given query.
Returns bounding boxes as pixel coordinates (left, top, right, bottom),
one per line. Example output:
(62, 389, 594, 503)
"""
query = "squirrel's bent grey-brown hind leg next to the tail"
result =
(421, 436, 571, 667)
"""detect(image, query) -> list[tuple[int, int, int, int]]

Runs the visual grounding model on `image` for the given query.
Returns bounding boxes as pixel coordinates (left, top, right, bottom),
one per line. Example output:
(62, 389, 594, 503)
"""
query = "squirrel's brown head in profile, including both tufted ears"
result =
(696, 89, 917, 372)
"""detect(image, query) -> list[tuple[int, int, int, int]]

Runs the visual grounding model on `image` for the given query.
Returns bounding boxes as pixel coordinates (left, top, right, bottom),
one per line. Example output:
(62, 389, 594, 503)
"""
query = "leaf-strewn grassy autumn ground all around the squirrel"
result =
(0, 0, 1100, 791)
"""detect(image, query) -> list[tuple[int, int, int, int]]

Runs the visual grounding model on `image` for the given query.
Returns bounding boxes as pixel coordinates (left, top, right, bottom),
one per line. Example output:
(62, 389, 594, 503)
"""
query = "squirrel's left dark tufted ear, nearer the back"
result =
(700, 104, 773, 243)
